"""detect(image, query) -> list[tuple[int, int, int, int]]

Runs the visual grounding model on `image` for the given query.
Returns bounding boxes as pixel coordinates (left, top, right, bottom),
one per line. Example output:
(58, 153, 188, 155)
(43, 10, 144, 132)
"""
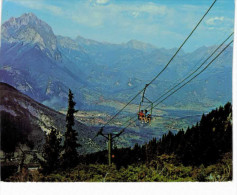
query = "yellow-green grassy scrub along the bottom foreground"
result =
(8, 153, 232, 182)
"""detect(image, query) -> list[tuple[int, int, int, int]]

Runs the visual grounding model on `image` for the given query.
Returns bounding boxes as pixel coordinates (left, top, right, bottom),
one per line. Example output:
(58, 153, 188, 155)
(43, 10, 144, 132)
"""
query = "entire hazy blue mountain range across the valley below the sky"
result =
(0, 13, 233, 112)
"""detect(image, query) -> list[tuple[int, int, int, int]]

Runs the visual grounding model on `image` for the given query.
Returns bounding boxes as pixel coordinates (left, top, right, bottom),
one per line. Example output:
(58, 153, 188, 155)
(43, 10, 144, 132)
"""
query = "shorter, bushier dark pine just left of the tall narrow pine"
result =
(40, 127, 62, 174)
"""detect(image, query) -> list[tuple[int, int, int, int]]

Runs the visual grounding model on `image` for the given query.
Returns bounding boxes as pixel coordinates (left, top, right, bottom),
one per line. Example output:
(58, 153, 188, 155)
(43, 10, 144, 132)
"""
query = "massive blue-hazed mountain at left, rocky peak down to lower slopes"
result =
(0, 13, 86, 107)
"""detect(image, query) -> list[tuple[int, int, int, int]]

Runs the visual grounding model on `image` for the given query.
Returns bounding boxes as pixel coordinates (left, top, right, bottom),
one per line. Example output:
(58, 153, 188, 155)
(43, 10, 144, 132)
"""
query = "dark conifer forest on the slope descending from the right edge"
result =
(82, 102, 232, 168)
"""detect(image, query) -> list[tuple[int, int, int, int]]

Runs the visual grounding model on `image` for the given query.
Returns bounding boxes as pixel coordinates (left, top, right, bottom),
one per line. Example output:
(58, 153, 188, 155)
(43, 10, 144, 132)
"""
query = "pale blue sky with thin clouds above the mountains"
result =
(2, 0, 234, 52)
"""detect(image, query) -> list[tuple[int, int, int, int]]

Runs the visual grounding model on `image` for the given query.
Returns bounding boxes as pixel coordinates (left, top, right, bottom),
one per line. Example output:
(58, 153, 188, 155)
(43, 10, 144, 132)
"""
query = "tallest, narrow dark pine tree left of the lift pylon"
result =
(62, 89, 81, 168)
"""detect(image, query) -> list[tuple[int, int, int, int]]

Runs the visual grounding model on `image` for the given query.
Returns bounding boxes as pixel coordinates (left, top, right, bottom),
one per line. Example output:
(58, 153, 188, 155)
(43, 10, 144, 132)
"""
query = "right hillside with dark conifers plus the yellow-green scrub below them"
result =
(6, 102, 232, 181)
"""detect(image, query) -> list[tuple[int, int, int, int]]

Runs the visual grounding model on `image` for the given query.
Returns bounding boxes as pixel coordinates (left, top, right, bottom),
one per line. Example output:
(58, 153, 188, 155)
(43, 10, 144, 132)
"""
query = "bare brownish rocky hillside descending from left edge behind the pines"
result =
(0, 83, 100, 153)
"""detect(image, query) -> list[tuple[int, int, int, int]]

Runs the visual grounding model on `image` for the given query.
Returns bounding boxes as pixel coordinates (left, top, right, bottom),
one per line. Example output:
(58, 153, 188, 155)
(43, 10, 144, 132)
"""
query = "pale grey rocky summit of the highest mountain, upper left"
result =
(2, 13, 61, 60)
